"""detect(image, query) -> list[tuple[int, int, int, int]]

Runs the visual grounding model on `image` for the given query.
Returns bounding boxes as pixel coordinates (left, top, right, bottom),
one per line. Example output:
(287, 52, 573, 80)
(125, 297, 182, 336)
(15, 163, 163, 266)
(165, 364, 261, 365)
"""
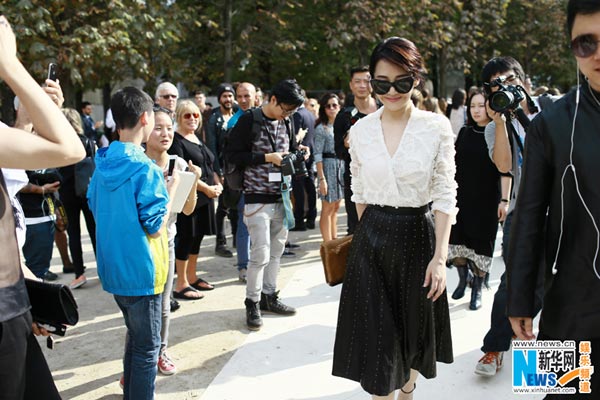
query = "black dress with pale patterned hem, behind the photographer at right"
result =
(448, 126, 500, 272)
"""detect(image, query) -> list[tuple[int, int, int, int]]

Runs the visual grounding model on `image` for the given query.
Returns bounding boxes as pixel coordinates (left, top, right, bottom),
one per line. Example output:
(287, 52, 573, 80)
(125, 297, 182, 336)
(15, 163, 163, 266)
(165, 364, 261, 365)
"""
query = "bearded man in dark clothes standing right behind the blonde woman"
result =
(206, 83, 237, 258)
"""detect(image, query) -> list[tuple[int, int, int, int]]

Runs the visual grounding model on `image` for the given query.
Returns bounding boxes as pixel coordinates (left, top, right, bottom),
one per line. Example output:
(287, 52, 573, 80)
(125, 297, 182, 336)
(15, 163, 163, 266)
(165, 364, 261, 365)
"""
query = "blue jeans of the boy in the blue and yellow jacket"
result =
(114, 294, 162, 400)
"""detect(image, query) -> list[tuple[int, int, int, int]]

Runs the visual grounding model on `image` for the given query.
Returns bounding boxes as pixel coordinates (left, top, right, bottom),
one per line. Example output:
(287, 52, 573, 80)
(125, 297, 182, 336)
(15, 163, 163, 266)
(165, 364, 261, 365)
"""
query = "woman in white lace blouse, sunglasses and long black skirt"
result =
(333, 37, 456, 399)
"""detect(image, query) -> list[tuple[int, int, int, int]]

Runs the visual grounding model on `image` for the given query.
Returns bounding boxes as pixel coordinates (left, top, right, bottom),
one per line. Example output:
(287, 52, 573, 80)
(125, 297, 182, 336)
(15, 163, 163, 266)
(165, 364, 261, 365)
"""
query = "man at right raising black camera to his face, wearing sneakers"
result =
(475, 57, 541, 376)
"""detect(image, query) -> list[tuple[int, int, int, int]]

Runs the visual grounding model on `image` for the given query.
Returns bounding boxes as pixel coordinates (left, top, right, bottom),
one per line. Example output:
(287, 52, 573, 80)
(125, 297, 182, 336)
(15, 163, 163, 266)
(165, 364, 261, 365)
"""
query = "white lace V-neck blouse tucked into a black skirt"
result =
(349, 107, 458, 216)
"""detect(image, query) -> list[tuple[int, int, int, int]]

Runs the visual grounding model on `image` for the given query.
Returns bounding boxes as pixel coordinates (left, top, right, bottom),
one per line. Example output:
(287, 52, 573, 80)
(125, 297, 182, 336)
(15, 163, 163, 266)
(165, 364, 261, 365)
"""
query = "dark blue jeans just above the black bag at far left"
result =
(23, 221, 54, 278)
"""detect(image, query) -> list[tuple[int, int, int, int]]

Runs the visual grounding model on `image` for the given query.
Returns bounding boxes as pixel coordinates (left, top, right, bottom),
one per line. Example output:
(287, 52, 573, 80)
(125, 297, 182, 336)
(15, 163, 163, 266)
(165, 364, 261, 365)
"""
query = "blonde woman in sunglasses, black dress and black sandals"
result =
(169, 100, 223, 300)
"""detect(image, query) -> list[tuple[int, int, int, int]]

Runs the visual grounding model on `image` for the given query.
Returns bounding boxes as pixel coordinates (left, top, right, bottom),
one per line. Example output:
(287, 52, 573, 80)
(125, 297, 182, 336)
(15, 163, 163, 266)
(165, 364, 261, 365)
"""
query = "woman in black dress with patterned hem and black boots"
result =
(448, 90, 500, 310)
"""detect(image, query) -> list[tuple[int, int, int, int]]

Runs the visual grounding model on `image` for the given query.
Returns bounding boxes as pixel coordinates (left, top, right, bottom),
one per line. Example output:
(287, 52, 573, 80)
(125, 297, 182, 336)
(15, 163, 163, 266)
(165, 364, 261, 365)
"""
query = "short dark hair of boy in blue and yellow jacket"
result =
(110, 86, 154, 129)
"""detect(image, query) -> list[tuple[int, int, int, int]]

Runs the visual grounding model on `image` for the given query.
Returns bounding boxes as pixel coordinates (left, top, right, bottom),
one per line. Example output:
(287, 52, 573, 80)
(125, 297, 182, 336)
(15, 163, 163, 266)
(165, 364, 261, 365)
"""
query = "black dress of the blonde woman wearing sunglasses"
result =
(168, 132, 217, 260)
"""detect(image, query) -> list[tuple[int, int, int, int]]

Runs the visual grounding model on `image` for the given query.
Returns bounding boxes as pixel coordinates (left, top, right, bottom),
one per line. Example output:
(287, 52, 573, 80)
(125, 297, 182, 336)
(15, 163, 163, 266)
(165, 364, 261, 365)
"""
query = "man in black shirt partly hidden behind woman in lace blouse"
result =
(333, 65, 379, 235)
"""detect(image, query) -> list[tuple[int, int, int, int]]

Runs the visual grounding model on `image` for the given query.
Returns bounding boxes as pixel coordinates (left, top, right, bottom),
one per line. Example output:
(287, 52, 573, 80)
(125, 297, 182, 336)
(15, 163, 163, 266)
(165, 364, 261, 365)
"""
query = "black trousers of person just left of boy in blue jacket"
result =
(60, 192, 96, 278)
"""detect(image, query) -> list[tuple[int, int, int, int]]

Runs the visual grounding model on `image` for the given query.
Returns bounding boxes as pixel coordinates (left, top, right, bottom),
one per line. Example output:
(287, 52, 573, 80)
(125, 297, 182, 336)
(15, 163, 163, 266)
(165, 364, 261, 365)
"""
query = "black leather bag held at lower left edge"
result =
(25, 279, 79, 336)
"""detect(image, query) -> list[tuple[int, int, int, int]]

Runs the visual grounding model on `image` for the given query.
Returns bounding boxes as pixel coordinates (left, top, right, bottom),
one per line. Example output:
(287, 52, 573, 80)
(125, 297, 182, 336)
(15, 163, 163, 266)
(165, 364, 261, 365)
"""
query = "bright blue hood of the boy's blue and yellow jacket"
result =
(95, 141, 148, 191)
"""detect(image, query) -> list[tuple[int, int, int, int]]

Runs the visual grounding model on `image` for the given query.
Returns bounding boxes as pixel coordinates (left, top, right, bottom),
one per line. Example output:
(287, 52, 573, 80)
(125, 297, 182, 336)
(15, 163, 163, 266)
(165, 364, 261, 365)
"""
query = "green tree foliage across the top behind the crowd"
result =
(0, 0, 574, 123)
